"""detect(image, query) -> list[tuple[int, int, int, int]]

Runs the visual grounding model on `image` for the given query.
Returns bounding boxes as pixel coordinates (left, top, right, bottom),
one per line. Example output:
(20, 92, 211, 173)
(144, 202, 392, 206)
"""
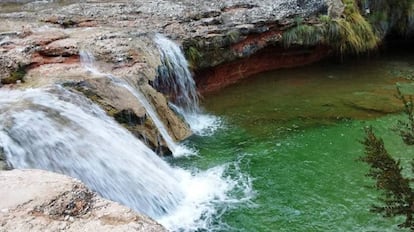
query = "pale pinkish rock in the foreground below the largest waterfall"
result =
(0, 170, 166, 232)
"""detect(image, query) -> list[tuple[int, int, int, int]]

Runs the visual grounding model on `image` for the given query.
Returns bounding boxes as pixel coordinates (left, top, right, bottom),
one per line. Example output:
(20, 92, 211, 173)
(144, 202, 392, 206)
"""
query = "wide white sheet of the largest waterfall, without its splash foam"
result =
(0, 89, 184, 217)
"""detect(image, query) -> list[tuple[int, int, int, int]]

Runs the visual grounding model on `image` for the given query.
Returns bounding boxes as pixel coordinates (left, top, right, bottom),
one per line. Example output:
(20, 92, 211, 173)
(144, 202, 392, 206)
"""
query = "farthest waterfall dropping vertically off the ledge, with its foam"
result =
(154, 34, 220, 135)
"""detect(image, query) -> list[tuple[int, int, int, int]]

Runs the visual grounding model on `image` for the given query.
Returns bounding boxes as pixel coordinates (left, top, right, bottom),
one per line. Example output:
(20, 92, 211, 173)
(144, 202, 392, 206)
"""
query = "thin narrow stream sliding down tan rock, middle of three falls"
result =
(80, 51, 193, 156)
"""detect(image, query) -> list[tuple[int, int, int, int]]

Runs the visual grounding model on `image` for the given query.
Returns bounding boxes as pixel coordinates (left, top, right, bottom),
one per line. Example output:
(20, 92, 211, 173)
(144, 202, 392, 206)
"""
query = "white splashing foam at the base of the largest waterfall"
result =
(158, 157, 256, 232)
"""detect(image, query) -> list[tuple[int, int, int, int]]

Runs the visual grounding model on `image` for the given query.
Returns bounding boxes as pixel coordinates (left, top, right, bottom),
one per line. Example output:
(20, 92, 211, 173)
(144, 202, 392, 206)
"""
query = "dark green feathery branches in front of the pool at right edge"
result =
(360, 88, 414, 231)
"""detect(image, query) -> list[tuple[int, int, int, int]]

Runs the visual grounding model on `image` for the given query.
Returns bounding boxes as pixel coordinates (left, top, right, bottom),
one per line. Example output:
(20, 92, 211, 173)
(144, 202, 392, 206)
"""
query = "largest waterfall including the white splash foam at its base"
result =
(0, 87, 253, 232)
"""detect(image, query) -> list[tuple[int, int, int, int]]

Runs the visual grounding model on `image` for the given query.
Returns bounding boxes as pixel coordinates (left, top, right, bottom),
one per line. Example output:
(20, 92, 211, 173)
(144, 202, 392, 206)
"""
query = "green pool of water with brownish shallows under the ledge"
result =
(173, 51, 414, 231)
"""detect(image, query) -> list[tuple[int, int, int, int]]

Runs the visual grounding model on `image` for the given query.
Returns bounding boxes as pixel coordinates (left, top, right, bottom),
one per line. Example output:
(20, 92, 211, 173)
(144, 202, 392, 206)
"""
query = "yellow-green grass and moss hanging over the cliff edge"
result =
(282, 0, 414, 54)
